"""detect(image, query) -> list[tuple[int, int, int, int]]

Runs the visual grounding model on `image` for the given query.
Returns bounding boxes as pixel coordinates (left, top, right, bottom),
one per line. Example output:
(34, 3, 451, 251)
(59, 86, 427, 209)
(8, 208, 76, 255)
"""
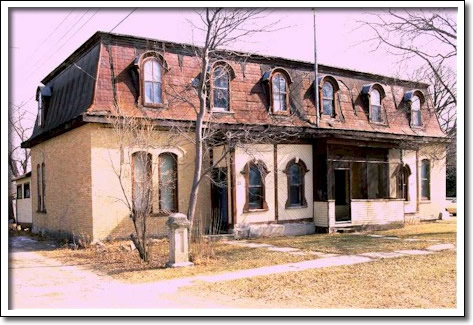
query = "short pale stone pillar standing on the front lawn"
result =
(166, 213, 194, 267)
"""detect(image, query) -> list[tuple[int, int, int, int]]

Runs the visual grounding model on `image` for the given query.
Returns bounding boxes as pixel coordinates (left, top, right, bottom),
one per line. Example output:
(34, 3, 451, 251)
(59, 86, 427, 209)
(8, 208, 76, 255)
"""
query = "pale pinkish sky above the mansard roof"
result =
(9, 8, 458, 131)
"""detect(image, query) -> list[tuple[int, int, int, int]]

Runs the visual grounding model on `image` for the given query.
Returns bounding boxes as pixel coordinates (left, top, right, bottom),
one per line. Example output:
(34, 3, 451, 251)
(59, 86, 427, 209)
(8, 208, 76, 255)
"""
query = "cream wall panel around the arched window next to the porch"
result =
(276, 144, 314, 221)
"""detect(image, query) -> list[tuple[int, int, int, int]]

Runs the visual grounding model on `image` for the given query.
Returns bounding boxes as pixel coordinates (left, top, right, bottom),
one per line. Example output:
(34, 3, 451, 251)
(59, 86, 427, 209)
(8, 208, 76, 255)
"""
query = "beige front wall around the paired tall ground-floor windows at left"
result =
(91, 125, 211, 239)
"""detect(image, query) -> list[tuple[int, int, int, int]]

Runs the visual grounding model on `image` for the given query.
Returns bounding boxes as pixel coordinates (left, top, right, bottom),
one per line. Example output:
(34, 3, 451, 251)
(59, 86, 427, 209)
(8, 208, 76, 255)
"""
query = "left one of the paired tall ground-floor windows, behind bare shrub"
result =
(132, 151, 152, 217)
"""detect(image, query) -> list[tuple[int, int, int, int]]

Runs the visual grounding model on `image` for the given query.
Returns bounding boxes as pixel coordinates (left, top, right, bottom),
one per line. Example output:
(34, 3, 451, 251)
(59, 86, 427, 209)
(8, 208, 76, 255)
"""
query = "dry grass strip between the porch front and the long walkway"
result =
(252, 221, 456, 254)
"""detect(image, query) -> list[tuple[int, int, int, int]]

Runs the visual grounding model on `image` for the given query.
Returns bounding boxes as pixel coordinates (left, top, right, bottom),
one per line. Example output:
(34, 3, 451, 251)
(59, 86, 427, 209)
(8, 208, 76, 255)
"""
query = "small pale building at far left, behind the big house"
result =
(13, 172, 33, 227)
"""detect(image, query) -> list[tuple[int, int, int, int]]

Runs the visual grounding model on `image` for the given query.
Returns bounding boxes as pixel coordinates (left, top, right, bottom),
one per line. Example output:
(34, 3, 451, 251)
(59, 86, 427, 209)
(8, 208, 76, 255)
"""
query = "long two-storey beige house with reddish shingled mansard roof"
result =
(22, 32, 446, 239)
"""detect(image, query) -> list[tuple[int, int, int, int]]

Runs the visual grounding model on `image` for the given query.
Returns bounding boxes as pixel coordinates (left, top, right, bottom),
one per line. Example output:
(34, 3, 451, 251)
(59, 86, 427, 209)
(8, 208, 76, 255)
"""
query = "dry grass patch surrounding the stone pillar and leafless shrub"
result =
(40, 239, 314, 283)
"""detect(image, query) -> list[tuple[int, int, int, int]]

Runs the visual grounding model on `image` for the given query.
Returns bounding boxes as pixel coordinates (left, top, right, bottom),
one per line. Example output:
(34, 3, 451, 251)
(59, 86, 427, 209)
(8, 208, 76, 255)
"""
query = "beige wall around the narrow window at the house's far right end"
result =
(417, 145, 447, 218)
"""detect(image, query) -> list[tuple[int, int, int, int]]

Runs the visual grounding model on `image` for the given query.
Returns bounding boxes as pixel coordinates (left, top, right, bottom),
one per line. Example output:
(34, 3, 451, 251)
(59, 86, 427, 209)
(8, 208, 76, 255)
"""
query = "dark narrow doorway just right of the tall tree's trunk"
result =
(208, 168, 228, 234)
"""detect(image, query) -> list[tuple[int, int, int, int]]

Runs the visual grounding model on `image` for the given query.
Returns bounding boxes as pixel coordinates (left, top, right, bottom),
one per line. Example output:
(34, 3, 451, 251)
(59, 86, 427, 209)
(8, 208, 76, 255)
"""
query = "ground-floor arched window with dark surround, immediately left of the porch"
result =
(284, 159, 308, 208)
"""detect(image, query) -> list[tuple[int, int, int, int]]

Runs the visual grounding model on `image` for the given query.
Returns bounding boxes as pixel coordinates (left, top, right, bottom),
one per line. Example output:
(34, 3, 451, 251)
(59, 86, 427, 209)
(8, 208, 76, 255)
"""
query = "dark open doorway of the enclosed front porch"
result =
(335, 169, 351, 222)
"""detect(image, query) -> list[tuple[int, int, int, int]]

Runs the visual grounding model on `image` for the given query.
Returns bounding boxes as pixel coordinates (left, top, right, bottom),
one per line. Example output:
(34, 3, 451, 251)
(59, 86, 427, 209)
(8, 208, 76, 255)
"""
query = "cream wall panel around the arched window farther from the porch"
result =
(235, 144, 275, 224)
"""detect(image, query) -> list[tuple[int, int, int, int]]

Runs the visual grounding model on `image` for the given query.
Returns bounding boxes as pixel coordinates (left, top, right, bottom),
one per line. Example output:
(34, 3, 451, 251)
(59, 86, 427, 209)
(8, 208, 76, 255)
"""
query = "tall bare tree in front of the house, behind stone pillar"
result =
(172, 8, 288, 232)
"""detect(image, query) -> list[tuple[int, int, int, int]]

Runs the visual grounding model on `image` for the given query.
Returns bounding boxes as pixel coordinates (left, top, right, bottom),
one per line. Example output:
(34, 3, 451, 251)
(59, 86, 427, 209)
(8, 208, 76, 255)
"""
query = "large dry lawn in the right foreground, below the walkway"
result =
(181, 251, 456, 309)
